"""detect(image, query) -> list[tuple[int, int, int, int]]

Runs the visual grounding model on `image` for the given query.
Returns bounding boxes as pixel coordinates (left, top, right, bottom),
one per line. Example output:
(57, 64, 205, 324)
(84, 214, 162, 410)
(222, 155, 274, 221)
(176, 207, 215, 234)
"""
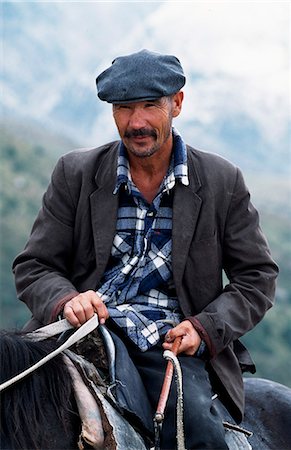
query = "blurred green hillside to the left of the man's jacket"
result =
(0, 121, 76, 328)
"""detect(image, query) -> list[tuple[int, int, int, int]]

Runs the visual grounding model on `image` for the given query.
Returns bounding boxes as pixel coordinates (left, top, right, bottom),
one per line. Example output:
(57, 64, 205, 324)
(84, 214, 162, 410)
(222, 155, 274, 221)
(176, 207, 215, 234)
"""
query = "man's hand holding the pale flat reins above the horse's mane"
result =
(63, 291, 109, 327)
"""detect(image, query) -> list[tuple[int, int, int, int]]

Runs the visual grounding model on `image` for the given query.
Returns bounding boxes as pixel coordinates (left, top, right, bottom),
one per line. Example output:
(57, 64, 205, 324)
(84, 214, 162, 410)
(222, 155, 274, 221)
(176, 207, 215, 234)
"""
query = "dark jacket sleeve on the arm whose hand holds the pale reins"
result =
(13, 159, 77, 324)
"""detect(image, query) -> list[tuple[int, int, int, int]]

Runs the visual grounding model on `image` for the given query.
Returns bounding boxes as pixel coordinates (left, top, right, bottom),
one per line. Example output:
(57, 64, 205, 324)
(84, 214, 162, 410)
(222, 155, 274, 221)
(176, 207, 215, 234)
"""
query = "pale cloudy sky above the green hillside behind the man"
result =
(0, 1, 291, 178)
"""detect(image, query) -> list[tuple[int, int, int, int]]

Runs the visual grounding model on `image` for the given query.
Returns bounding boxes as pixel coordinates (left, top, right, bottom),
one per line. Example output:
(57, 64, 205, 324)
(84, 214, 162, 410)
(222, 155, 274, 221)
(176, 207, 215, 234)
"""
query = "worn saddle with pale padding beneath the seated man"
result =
(65, 326, 252, 450)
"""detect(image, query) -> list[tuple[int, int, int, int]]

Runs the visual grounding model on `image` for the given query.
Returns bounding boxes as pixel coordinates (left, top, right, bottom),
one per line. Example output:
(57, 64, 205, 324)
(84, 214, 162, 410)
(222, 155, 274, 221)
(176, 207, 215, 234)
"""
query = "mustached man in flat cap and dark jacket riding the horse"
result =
(13, 50, 277, 449)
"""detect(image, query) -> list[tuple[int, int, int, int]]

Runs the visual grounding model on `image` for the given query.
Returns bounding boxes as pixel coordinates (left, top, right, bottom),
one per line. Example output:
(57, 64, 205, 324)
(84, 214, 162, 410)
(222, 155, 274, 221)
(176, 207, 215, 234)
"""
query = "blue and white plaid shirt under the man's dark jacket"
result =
(97, 129, 189, 351)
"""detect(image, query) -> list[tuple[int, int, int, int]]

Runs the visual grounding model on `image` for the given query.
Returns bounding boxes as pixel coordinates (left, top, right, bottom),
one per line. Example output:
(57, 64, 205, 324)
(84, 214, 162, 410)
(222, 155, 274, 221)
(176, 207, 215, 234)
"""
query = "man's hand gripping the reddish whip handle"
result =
(163, 320, 201, 355)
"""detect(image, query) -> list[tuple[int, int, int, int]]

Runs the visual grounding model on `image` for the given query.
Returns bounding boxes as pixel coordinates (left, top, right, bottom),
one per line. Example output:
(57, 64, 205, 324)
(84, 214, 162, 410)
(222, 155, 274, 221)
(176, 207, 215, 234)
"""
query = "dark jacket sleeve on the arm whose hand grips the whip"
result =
(192, 169, 278, 356)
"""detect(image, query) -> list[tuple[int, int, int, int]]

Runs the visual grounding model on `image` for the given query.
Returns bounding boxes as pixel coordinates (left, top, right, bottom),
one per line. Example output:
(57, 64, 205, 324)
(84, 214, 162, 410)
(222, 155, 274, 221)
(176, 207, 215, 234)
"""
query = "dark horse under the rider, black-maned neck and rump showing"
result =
(0, 332, 291, 450)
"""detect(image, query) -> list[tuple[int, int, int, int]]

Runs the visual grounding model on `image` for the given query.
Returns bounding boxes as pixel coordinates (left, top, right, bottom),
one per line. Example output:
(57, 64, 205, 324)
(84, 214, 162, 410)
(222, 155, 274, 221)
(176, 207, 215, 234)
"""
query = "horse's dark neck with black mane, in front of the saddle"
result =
(0, 333, 81, 450)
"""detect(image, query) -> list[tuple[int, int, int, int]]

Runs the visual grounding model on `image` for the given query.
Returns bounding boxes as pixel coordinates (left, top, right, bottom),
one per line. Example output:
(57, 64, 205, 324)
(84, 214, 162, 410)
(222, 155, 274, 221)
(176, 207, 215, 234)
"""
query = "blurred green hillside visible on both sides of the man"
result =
(0, 119, 291, 386)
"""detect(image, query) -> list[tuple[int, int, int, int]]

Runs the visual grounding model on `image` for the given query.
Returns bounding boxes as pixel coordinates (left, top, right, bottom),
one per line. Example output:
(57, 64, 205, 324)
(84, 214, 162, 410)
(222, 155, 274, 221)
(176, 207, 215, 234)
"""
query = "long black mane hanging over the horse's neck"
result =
(0, 331, 76, 449)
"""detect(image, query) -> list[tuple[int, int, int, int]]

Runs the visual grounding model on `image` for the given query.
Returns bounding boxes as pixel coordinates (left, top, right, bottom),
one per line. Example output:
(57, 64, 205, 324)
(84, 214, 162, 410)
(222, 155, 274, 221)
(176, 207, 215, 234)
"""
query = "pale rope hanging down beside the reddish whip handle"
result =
(163, 350, 186, 450)
